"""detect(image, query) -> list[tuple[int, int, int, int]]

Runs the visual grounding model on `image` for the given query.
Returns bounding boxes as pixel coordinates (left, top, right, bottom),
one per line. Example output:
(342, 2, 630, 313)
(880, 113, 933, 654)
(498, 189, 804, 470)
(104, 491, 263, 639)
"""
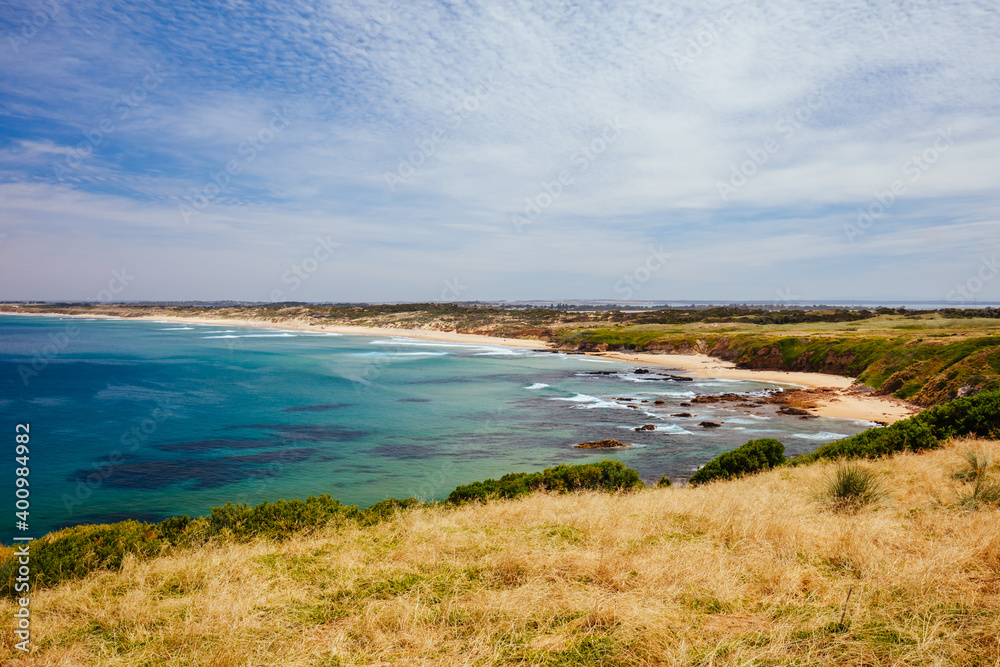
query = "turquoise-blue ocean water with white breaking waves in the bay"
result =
(0, 315, 871, 543)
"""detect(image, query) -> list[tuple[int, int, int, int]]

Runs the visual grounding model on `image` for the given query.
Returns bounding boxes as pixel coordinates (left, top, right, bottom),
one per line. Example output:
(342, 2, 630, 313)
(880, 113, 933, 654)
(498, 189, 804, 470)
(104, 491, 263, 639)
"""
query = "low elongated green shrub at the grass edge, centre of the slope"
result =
(445, 460, 643, 504)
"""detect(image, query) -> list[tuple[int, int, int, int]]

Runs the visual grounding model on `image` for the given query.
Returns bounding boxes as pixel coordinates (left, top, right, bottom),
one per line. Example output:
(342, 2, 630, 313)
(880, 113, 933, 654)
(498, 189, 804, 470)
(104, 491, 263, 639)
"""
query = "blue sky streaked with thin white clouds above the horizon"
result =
(0, 0, 1000, 304)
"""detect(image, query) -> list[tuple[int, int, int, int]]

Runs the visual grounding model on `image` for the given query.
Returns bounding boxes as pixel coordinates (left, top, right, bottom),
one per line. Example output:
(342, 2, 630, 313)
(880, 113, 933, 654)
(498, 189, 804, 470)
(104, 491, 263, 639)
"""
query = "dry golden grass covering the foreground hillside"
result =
(0, 440, 1000, 666)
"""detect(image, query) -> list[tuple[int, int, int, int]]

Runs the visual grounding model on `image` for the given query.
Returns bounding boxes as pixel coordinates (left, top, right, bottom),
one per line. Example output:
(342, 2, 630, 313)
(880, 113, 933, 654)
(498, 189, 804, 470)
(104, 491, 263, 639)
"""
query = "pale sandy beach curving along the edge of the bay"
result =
(3, 312, 921, 424)
